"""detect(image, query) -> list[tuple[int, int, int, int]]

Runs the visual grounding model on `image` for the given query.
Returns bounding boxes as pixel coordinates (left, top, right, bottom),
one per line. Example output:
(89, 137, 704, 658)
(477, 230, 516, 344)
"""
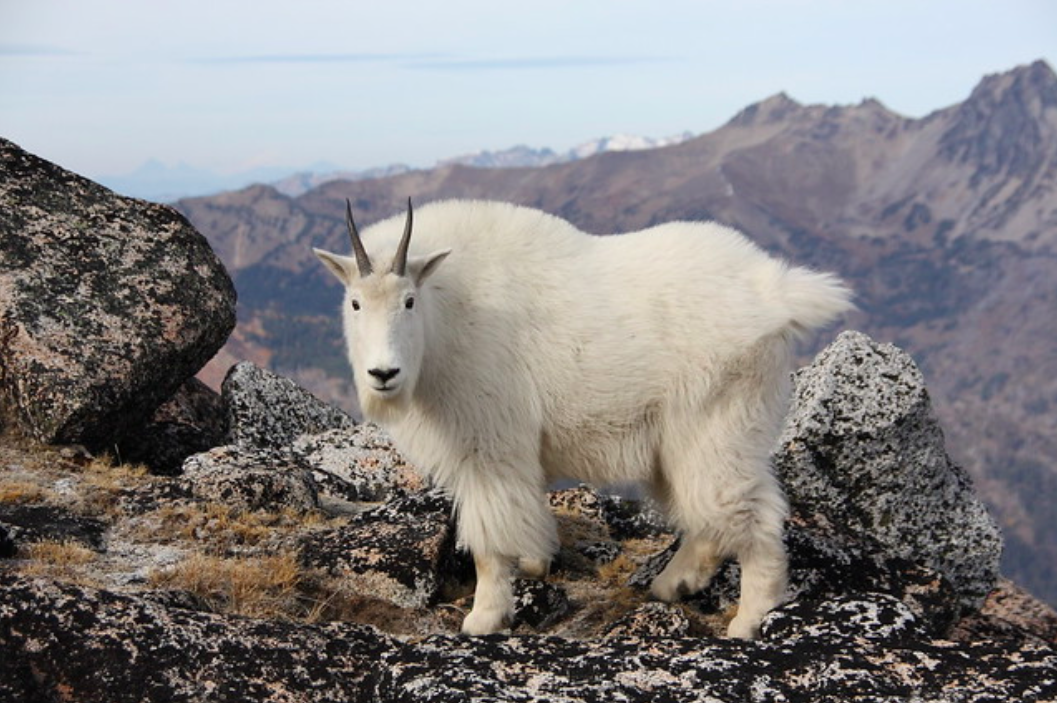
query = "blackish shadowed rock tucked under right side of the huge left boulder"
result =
(118, 378, 227, 476)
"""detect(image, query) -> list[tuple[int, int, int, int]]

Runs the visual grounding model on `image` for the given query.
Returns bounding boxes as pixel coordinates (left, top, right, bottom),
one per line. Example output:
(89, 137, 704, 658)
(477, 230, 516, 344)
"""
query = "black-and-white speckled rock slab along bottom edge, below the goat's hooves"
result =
(378, 613, 1057, 703)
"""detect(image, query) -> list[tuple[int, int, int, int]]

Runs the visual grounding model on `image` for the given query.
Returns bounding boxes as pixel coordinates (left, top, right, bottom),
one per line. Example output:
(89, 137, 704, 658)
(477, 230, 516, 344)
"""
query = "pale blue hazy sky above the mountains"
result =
(0, 0, 1057, 177)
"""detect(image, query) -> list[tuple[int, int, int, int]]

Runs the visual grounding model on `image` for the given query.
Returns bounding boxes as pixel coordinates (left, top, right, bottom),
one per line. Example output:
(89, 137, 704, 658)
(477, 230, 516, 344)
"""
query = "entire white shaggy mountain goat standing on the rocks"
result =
(315, 195, 851, 637)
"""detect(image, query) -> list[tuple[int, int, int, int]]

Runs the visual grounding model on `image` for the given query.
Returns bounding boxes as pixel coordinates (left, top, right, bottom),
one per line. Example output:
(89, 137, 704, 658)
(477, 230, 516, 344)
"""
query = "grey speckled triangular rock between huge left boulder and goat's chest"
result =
(221, 362, 355, 449)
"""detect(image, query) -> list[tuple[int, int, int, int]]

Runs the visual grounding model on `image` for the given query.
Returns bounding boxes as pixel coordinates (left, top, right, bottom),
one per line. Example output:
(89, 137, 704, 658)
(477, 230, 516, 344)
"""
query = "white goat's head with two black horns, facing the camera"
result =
(314, 199, 450, 408)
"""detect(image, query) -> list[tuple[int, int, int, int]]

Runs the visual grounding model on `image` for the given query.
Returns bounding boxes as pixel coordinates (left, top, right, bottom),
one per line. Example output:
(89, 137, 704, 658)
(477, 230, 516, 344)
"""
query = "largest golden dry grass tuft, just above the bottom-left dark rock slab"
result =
(150, 553, 311, 619)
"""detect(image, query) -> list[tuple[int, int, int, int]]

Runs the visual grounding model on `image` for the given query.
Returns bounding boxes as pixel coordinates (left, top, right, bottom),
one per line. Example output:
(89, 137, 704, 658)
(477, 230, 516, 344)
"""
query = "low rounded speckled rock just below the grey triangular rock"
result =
(182, 445, 319, 512)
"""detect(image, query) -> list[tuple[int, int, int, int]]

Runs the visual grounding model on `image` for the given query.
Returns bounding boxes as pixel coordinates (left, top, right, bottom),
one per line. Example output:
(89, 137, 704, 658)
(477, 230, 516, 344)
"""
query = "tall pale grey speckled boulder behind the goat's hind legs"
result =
(775, 332, 1002, 609)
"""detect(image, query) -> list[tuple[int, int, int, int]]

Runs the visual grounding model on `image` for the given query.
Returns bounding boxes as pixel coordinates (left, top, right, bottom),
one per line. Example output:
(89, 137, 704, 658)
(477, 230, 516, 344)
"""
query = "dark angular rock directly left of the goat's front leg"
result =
(301, 493, 468, 608)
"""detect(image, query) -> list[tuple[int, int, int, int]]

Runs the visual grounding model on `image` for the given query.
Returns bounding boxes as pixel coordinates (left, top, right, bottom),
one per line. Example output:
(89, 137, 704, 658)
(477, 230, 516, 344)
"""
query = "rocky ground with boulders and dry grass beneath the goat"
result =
(0, 134, 1057, 702)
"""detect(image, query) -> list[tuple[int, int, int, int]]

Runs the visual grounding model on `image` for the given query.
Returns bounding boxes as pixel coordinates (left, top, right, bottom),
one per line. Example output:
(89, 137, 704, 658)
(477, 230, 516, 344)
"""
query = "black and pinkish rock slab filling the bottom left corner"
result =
(0, 572, 398, 703)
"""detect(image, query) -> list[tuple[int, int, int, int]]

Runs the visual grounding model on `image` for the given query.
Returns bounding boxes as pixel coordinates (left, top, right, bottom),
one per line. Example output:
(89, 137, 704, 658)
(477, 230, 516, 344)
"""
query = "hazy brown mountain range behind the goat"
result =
(179, 61, 1057, 603)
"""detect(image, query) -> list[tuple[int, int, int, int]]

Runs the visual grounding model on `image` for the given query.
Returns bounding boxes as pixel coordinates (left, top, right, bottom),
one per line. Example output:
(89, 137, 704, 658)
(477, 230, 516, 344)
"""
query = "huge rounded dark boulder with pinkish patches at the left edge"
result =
(0, 140, 235, 448)
